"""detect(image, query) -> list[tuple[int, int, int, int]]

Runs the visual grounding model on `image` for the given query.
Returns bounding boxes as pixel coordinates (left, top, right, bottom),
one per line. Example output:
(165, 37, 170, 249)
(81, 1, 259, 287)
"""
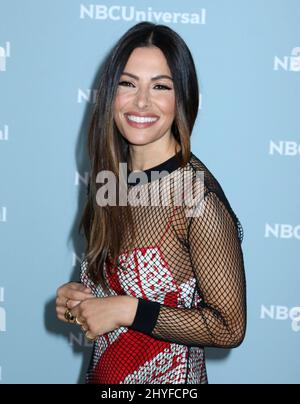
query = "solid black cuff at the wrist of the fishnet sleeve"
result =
(130, 297, 160, 334)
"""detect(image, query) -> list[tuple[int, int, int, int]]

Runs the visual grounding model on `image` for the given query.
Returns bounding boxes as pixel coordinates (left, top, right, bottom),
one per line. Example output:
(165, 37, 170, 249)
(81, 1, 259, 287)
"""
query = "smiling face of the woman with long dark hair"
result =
(114, 47, 175, 145)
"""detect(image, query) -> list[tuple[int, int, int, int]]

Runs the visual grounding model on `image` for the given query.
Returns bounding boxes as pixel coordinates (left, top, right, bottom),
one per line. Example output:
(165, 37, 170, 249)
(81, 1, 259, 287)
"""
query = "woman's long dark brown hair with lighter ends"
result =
(79, 22, 199, 289)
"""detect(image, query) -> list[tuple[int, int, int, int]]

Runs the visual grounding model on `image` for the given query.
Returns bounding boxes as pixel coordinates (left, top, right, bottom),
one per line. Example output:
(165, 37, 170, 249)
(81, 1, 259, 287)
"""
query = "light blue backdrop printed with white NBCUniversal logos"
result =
(0, 0, 300, 384)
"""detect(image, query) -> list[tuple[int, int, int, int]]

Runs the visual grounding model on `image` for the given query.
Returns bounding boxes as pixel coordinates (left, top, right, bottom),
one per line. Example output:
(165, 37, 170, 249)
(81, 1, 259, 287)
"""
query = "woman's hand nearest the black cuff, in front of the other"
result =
(70, 295, 138, 339)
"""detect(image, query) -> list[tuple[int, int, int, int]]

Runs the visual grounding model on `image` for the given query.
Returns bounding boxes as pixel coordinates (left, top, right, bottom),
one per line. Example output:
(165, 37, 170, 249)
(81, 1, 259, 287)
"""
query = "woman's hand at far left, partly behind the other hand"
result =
(56, 282, 94, 322)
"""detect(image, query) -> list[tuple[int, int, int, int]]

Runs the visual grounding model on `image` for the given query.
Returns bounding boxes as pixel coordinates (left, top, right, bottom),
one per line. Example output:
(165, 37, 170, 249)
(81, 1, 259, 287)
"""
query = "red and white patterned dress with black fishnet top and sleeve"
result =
(81, 152, 246, 384)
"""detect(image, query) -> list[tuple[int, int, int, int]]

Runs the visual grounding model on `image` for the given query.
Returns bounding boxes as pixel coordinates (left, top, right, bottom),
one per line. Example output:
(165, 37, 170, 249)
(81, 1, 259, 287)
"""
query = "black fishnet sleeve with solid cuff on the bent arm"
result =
(131, 192, 246, 348)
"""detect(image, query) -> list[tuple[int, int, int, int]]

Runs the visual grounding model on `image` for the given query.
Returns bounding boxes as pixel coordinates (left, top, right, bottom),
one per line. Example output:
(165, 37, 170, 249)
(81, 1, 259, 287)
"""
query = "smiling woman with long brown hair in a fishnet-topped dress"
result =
(57, 22, 246, 384)
